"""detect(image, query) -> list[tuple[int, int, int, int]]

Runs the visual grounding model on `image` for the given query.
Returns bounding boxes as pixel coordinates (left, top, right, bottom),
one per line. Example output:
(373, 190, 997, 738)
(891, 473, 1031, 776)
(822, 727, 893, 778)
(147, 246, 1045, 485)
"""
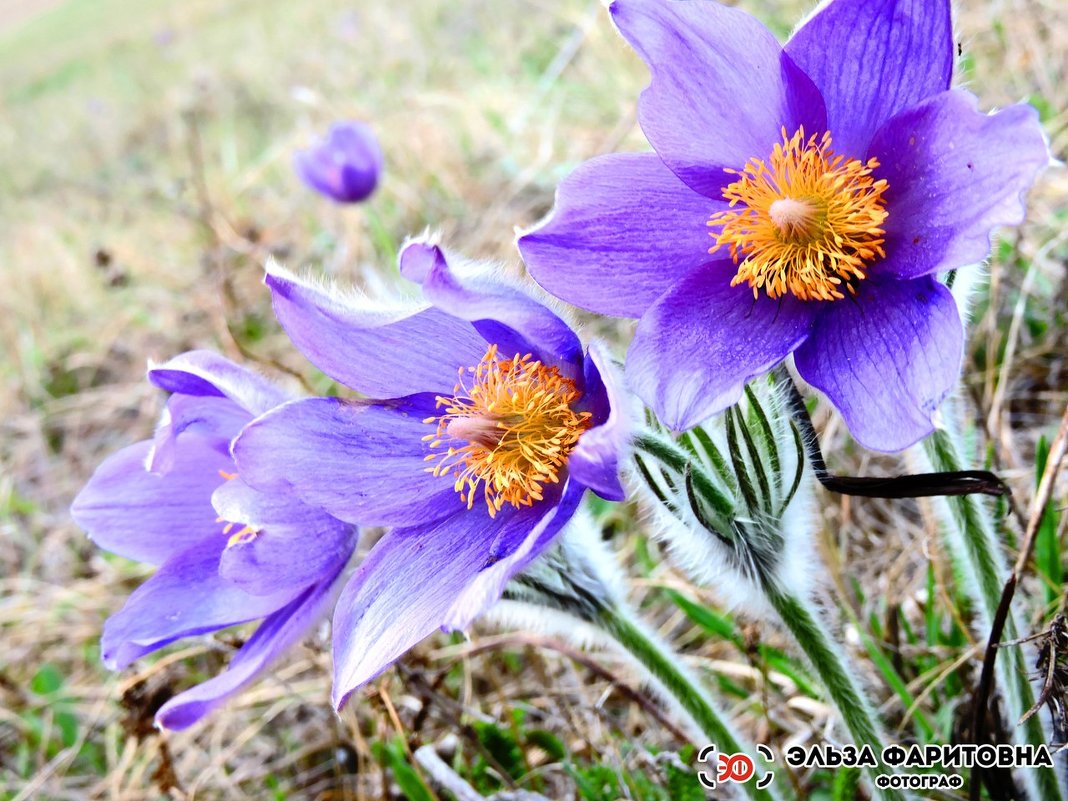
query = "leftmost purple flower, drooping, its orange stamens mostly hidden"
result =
(70, 350, 356, 728)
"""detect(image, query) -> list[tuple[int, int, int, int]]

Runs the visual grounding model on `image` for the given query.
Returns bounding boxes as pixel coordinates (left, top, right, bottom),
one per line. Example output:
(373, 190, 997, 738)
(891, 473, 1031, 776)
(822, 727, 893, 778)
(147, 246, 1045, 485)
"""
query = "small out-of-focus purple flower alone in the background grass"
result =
(293, 122, 382, 203)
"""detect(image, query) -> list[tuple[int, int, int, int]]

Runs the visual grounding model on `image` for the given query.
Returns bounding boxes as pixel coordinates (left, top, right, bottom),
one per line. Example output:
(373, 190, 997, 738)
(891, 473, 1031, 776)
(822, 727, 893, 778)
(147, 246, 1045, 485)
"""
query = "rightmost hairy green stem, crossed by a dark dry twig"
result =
(924, 402, 1063, 801)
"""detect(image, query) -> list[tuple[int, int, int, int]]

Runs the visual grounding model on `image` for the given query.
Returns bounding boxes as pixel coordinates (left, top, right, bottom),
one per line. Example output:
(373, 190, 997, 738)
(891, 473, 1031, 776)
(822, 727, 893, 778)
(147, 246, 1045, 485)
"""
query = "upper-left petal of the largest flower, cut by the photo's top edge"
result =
(609, 0, 827, 199)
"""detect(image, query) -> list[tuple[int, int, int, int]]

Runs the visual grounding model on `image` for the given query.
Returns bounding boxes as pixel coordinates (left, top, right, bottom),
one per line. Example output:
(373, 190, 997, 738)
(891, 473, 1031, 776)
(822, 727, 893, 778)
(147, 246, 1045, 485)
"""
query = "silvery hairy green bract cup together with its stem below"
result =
(634, 377, 901, 799)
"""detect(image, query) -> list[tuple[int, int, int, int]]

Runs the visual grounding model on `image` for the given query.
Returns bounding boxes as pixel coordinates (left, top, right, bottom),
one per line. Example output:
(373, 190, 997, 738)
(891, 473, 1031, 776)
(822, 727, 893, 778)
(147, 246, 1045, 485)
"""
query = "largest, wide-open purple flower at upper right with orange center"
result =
(519, 0, 1049, 451)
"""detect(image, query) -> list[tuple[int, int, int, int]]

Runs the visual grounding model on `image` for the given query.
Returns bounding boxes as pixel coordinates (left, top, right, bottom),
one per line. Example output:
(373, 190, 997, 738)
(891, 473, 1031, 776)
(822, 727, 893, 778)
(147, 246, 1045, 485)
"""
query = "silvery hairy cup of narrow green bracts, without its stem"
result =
(634, 378, 814, 615)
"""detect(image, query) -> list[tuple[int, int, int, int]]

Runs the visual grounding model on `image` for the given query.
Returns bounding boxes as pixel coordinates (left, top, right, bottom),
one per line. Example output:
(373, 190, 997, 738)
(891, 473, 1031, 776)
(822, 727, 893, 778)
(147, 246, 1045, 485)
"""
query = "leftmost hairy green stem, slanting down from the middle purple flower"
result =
(598, 607, 781, 801)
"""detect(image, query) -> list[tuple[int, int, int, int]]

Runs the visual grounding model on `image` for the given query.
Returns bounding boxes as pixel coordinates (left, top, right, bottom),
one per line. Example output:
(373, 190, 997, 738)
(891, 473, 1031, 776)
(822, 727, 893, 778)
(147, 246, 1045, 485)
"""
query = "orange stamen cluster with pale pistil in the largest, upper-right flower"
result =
(708, 127, 886, 300)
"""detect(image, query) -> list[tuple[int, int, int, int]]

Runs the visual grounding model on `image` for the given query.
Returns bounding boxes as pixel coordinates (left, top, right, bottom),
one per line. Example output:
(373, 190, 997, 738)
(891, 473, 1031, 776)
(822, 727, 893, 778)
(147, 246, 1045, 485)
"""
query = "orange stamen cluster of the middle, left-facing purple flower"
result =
(423, 345, 591, 517)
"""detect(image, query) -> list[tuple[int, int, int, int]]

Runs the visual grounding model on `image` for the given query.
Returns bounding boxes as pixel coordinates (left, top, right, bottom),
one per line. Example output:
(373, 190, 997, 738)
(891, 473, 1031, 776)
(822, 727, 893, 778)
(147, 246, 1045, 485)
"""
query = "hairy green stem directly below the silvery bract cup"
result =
(764, 584, 904, 799)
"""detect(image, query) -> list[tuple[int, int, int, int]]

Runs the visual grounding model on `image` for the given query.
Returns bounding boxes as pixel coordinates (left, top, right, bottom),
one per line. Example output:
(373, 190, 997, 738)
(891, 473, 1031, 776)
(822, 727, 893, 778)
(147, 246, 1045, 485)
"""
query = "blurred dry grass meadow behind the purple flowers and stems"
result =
(0, 0, 1068, 801)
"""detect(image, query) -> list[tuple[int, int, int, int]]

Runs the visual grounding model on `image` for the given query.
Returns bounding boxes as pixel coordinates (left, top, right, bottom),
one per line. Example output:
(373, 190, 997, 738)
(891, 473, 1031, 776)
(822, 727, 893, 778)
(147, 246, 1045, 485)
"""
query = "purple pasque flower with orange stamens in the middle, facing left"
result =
(234, 241, 627, 708)
